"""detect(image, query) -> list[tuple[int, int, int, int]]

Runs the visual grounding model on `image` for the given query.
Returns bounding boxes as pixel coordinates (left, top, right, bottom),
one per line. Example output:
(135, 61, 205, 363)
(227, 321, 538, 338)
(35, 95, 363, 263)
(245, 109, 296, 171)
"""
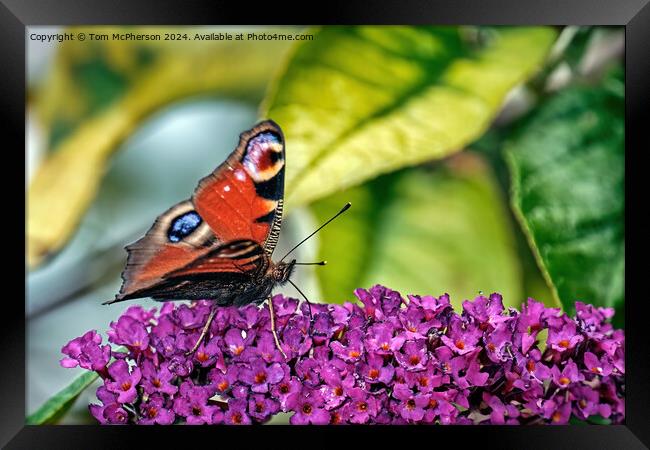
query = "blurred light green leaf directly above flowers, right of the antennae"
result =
(312, 153, 522, 307)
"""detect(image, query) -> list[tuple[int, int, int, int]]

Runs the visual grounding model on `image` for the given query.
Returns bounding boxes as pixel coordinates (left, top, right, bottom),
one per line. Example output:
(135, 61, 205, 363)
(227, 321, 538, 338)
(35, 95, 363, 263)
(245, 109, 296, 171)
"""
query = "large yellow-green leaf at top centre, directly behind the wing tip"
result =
(262, 26, 556, 207)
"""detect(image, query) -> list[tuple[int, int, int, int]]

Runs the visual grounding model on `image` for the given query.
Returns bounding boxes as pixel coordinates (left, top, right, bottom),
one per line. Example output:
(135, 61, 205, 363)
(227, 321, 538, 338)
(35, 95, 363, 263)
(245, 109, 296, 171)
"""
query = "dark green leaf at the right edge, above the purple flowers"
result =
(505, 76, 625, 320)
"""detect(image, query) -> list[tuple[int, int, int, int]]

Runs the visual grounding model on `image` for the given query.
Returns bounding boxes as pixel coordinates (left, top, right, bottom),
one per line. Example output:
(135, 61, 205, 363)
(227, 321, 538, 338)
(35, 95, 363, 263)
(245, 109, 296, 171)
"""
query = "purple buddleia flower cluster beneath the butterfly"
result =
(61, 286, 625, 425)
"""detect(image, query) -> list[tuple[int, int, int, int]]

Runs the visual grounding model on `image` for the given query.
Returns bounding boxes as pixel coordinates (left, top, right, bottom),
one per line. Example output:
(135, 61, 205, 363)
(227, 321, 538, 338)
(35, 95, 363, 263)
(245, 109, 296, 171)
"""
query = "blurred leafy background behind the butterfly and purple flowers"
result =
(25, 26, 624, 423)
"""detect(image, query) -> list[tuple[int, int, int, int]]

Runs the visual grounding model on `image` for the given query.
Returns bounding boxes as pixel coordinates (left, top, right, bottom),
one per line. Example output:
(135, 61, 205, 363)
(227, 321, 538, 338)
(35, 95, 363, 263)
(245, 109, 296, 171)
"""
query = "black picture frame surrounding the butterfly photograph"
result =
(6, 0, 650, 450)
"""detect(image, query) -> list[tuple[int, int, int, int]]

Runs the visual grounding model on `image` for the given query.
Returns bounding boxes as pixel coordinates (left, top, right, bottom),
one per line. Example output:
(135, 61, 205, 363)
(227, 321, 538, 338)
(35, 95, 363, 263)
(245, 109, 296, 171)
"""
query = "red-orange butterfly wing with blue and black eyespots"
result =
(114, 121, 285, 301)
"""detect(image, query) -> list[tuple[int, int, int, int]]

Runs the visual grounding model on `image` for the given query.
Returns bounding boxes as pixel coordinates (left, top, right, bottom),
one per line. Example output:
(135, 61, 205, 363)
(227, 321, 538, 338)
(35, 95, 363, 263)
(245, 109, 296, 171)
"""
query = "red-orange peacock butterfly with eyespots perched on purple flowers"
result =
(104, 120, 349, 353)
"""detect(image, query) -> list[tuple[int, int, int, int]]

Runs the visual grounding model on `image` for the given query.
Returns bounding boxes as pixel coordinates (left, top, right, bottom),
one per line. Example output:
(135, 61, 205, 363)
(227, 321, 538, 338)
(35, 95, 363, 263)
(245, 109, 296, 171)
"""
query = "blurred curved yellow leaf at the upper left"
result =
(27, 28, 296, 266)
